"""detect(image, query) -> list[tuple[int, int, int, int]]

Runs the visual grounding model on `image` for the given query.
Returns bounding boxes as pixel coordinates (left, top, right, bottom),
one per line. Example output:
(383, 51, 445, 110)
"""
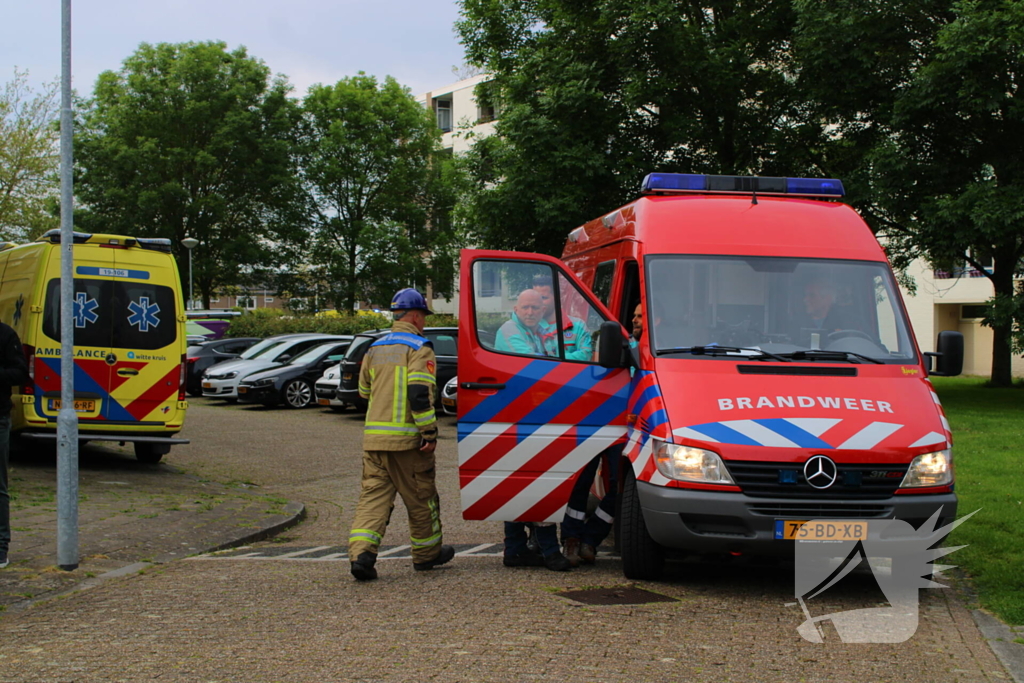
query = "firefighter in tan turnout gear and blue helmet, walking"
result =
(348, 288, 455, 581)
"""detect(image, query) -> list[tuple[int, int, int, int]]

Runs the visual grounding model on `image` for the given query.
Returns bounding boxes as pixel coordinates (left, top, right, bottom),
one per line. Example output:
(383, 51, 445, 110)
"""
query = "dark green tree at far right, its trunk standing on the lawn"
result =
(797, 0, 1024, 386)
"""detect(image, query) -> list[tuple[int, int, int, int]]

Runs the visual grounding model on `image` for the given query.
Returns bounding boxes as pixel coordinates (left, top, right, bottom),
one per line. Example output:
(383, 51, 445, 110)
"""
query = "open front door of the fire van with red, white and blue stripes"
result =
(458, 250, 631, 521)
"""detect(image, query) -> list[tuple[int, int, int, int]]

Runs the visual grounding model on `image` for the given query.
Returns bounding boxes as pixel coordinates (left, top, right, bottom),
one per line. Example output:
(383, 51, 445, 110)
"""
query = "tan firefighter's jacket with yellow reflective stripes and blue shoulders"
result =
(359, 321, 437, 451)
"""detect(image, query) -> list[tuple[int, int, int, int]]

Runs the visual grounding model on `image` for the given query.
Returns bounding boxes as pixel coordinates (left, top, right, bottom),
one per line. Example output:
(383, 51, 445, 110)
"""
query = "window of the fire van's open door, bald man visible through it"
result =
(473, 260, 603, 362)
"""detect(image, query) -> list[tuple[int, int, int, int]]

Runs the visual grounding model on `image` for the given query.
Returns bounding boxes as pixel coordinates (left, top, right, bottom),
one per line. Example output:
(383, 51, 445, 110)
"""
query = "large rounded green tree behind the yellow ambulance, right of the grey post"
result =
(76, 42, 298, 306)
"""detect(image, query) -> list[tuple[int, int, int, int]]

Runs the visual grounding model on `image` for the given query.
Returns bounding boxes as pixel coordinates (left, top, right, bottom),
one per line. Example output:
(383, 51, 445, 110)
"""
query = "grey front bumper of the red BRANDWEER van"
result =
(637, 481, 956, 557)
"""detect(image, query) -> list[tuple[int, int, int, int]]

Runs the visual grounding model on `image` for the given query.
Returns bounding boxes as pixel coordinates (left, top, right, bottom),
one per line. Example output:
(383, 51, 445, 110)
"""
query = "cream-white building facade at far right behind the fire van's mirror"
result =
(902, 259, 1024, 377)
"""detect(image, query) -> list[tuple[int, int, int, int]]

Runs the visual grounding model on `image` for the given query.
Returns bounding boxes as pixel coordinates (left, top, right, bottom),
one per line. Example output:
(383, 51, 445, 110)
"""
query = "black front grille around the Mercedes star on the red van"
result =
(726, 461, 907, 500)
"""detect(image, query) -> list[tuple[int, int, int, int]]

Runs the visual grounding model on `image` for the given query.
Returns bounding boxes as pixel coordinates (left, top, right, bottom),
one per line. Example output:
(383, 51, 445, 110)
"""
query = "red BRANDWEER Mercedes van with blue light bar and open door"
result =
(458, 173, 963, 579)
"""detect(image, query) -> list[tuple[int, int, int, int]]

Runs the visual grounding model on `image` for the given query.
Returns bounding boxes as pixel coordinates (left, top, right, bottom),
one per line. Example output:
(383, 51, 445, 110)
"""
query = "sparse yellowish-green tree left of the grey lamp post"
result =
(0, 69, 60, 240)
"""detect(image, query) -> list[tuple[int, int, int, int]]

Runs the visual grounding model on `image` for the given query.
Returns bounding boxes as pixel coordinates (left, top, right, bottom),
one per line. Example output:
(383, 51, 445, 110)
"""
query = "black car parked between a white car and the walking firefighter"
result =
(239, 338, 351, 408)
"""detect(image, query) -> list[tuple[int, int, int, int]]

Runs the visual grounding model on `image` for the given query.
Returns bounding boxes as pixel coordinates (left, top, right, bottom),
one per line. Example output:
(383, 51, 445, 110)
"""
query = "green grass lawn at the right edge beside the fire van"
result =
(932, 377, 1024, 625)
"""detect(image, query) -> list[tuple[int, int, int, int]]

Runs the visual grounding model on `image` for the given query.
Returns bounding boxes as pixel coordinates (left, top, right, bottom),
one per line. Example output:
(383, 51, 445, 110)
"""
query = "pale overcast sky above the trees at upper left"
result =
(0, 0, 464, 95)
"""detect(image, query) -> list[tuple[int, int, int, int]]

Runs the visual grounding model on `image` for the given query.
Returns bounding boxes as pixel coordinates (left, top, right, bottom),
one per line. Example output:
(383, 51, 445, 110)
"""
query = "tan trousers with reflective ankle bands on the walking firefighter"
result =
(348, 450, 441, 562)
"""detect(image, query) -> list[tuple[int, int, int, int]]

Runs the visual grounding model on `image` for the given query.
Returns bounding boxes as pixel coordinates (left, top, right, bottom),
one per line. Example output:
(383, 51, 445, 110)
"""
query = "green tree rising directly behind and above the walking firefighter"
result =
(299, 73, 447, 311)
